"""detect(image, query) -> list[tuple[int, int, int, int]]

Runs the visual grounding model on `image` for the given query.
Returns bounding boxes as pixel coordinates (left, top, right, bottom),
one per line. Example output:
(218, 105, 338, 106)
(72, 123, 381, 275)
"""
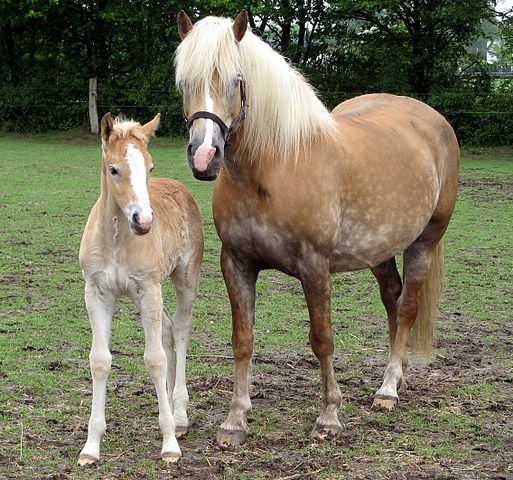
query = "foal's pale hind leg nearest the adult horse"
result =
(168, 255, 200, 437)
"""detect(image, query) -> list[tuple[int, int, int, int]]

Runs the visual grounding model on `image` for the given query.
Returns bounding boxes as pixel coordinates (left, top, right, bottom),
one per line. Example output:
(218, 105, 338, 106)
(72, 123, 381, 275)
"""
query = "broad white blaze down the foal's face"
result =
(126, 143, 153, 224)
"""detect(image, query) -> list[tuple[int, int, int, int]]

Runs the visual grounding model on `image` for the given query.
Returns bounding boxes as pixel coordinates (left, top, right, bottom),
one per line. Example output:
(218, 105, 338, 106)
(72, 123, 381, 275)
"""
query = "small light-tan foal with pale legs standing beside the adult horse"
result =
(78, 113, 203, 465)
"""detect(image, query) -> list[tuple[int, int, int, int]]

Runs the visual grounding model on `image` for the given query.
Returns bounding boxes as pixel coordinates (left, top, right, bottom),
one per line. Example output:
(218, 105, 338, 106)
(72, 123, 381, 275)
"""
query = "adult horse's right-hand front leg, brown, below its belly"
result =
(301, 255, 342, 440)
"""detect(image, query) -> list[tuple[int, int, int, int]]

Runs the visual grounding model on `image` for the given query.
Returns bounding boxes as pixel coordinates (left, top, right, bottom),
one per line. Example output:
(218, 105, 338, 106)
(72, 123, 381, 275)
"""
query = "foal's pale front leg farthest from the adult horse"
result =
(78, 282, 116, 465)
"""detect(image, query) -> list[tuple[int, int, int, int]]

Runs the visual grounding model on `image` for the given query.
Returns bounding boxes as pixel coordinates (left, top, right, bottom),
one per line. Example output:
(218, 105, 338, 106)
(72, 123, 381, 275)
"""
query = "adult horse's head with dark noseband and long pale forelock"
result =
(176, 10, 248, 180)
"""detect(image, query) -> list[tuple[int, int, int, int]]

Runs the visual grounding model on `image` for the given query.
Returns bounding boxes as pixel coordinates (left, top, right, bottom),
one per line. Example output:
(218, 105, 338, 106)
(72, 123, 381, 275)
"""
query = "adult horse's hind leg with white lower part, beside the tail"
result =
(372, 241, 436, 410)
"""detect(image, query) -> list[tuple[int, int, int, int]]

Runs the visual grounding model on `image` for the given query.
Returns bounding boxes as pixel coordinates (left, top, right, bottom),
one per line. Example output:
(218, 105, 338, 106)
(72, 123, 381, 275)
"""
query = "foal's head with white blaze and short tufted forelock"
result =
(101, 113, 160, 235)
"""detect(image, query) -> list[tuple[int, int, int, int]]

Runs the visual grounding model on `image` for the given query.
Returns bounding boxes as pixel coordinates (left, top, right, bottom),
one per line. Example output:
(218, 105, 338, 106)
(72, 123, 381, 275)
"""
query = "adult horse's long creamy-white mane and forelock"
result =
(175, 17, 336, 162)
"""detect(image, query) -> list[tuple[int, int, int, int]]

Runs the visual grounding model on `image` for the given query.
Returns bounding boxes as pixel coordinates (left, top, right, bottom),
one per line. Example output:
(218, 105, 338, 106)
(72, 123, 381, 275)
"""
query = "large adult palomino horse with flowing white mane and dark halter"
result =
(175, 11, 459, 446)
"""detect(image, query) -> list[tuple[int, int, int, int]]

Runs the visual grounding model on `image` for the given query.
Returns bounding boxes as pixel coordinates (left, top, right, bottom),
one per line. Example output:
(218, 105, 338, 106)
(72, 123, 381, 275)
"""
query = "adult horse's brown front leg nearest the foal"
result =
(217, 247, 258, 447)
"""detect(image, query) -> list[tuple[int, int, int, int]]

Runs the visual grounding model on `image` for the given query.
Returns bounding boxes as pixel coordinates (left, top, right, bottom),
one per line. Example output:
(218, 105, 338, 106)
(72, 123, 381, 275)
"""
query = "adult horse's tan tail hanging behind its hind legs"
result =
(410, 237, 445, 361)
